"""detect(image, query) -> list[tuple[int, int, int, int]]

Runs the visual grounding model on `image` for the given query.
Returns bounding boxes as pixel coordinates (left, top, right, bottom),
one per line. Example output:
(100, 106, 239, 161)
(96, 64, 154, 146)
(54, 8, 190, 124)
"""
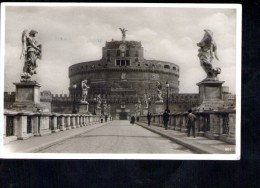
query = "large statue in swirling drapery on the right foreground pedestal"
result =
(197, 29, 221, 80)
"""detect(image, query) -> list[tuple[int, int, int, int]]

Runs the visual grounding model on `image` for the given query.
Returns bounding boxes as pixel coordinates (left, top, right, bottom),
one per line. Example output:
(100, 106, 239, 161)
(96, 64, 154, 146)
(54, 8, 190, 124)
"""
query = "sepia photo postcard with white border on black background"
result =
(0, 3, 242, 160)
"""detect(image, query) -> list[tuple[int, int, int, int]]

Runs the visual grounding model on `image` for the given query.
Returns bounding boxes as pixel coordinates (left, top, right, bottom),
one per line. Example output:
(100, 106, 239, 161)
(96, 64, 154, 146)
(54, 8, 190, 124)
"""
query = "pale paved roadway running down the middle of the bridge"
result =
(39, 120, 193, 154)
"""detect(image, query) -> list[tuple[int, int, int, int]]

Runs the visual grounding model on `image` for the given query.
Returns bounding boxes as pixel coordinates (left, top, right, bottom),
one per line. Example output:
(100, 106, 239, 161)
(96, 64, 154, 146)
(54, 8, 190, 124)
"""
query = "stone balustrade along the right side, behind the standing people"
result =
(139, 110, 236, 144)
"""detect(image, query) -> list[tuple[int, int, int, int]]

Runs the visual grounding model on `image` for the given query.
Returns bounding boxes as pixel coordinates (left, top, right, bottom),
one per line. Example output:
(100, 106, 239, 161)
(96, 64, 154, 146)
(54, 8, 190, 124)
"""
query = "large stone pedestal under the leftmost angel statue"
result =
(13, 81, 49, 112)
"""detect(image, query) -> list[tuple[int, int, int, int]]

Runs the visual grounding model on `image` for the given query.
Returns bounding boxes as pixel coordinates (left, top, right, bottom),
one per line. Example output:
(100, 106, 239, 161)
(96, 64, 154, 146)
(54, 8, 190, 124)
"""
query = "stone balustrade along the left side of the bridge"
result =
(3, 112, 101, 143)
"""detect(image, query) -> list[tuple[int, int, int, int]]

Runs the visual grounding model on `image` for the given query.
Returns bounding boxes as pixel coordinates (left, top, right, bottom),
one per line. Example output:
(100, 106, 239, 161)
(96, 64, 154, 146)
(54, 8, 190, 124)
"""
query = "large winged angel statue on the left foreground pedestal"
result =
(20, 29, 42, 81)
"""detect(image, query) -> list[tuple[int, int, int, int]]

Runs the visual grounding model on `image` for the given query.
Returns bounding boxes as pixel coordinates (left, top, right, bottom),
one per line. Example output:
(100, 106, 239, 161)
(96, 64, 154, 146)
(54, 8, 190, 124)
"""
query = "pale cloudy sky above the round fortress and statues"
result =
(2, 6, 237, 94)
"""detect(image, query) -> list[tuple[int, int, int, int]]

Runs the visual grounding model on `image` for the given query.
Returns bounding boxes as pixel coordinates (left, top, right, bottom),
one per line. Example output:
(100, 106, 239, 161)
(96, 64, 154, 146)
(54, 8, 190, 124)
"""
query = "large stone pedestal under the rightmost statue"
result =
(197, 80, 224, 111)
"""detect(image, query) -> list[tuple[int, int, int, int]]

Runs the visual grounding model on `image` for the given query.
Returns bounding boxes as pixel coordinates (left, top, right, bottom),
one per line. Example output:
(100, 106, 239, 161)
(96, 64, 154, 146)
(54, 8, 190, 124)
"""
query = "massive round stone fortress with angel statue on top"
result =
(69, 30, 183, 119)
